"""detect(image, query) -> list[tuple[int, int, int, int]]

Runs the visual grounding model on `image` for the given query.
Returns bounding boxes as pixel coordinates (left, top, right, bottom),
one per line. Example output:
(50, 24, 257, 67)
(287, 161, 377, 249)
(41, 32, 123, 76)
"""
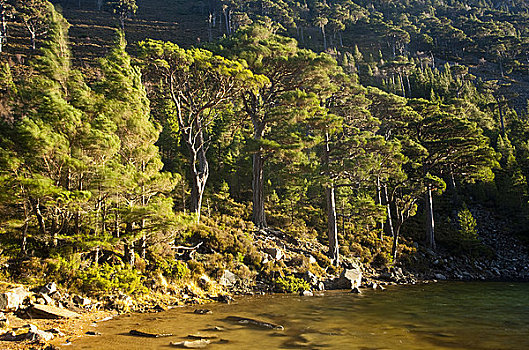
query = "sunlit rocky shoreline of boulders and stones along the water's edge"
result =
(0, 206, 529, 349)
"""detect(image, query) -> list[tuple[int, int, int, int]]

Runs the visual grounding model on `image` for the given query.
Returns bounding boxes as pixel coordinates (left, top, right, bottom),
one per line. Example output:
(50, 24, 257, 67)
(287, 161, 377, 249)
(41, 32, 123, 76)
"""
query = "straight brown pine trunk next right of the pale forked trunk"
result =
(252, 121, 267, 228)
